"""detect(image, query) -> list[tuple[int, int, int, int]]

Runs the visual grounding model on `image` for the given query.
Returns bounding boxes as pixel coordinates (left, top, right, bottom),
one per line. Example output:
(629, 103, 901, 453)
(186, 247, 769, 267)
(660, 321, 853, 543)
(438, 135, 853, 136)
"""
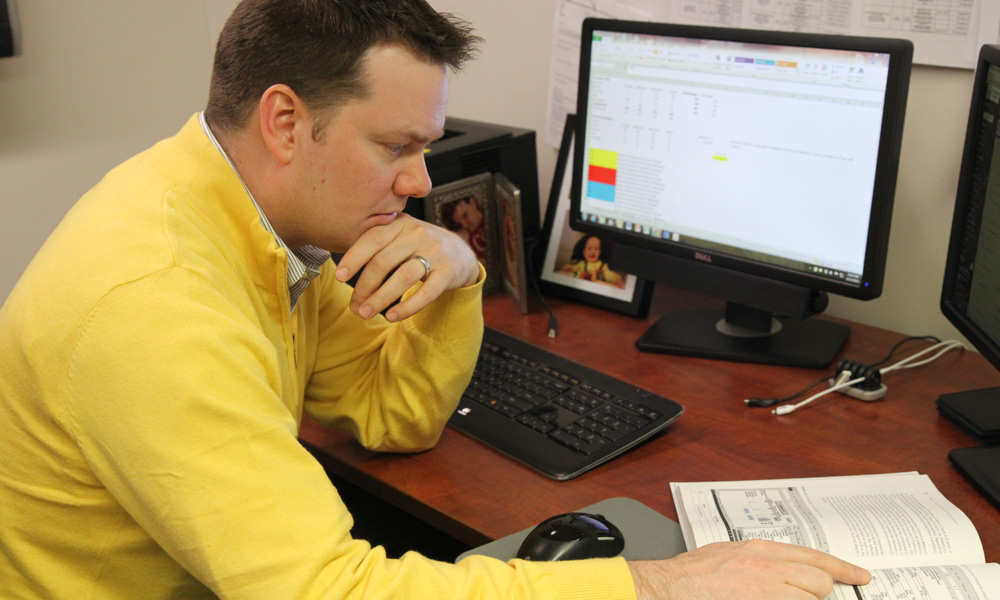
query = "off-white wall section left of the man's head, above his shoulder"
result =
(0, 0, 212, 308)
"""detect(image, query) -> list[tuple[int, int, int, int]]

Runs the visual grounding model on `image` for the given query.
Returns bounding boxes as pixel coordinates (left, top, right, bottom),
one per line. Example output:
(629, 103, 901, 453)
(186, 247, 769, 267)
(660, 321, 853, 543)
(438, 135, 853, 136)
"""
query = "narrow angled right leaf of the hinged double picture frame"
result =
(494, 173, 528, 314)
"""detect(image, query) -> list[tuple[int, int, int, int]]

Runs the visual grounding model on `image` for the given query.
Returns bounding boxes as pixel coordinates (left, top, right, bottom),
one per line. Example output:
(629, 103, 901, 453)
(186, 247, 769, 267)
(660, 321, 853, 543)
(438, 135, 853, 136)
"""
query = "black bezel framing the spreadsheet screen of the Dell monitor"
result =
(570, 18, 913, 300)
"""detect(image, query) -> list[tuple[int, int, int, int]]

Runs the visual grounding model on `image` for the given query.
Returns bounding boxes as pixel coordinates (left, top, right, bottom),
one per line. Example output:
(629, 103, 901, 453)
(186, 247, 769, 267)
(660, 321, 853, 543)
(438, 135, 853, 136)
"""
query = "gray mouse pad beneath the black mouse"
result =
(458, 498, 687, 561)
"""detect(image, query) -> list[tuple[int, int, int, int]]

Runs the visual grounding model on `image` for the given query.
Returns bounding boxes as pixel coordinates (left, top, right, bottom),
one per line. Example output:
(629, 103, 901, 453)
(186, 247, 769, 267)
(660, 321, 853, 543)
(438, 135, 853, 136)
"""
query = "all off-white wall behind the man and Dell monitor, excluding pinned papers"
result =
(0, 0, 972, 346)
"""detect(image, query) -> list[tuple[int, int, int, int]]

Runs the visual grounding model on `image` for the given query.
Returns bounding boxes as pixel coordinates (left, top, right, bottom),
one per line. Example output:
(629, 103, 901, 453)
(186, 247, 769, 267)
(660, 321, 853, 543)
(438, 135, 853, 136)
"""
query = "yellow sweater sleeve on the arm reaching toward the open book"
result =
(60, 269, 634, 600)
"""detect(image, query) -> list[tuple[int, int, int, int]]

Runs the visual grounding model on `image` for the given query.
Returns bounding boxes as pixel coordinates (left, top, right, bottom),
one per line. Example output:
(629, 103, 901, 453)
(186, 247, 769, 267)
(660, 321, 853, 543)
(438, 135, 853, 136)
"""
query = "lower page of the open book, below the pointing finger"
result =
(827, 563, 1000, 600)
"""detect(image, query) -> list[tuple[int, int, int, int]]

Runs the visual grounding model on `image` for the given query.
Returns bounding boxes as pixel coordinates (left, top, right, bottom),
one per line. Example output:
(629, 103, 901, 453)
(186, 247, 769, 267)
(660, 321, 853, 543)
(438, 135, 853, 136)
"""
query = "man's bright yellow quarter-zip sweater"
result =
(0, 118, 634, 600)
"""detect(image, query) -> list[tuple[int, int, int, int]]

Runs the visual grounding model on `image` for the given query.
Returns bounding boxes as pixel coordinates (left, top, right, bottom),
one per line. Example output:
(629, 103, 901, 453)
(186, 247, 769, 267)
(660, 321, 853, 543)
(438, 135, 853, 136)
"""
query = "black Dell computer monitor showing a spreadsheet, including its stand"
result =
(570, 19, 913, 368)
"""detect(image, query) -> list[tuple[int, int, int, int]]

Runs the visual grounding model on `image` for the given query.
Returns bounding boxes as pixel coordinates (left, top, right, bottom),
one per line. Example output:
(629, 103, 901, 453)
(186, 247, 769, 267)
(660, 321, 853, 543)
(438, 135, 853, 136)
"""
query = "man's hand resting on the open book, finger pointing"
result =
(629, 540, 871, 600)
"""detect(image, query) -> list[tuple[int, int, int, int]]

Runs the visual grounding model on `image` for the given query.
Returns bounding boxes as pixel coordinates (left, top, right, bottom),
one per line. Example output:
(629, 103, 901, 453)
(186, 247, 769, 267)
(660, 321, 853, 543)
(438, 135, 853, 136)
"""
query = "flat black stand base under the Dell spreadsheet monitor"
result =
(635, 303, 851, 369)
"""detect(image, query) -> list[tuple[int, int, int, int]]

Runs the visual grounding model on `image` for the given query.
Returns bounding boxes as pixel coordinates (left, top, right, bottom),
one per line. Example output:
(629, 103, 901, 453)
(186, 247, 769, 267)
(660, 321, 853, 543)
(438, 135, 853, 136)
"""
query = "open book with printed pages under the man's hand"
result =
(670, 473, 1000, 600)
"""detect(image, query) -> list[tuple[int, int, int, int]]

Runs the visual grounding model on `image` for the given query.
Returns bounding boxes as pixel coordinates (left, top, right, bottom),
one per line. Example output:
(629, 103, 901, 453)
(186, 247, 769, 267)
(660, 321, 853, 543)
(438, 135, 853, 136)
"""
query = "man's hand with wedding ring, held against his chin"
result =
(337, 213, 479, 321)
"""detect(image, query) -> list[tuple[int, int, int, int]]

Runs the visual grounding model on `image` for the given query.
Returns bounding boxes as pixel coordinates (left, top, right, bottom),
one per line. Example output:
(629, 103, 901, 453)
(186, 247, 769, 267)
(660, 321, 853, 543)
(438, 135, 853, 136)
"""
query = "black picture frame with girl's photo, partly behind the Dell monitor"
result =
(533, 114, 653, 318)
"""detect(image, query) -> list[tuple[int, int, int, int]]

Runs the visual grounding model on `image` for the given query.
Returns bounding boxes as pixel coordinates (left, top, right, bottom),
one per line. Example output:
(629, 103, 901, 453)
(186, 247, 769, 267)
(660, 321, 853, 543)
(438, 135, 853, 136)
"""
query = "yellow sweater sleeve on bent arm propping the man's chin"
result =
(305, 266, 485, 452)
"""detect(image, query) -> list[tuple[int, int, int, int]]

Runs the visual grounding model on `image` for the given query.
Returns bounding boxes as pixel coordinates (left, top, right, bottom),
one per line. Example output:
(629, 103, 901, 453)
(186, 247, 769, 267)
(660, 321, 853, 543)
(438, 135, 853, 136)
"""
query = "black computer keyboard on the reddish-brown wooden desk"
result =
(448, 327, 684, 480)
